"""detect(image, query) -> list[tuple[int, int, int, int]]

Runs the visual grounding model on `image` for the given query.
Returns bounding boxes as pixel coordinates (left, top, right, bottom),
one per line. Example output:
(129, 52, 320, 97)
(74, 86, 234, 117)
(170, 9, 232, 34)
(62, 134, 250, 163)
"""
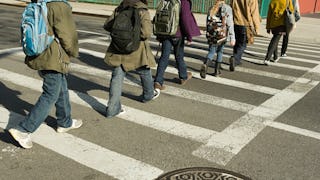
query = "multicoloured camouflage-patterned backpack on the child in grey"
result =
(206, 5, 228, 44)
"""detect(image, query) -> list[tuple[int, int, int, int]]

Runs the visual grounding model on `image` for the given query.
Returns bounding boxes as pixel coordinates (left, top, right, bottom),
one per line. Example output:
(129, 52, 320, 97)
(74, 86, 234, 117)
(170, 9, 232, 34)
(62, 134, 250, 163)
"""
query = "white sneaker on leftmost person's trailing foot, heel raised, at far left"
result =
(9, 127, 32, 149)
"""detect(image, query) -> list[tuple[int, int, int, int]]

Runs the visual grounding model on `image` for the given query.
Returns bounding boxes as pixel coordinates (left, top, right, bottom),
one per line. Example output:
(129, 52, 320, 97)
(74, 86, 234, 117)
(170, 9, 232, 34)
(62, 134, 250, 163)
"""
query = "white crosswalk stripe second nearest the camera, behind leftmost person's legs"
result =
(0, 68, 216, 143)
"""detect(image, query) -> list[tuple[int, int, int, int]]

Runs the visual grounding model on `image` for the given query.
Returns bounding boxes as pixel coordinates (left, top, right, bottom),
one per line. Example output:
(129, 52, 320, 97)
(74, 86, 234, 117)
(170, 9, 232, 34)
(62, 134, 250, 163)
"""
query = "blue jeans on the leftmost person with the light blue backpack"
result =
(19, 71, 72, 133)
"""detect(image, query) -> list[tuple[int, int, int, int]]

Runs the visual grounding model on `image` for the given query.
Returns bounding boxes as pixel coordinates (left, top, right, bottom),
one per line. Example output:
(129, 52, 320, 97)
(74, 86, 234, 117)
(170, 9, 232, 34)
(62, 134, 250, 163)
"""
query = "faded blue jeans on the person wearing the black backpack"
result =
(107, 66, 154, 117)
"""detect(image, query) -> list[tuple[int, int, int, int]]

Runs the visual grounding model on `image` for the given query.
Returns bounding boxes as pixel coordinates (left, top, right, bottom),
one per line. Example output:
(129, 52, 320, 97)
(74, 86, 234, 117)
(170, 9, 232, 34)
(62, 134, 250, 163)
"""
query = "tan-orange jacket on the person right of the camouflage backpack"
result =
(230, 0, 261, 33)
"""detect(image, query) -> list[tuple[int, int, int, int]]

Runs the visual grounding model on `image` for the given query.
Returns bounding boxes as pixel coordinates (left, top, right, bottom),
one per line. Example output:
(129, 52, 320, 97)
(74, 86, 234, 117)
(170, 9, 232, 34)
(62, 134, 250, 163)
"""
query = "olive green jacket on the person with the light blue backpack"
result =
(25, 2, 79, 74)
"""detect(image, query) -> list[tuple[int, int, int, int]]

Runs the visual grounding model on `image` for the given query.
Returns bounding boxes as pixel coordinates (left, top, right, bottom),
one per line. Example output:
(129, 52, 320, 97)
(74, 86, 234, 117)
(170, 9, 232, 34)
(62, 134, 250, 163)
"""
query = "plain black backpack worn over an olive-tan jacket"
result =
(110, 6, 141, 54)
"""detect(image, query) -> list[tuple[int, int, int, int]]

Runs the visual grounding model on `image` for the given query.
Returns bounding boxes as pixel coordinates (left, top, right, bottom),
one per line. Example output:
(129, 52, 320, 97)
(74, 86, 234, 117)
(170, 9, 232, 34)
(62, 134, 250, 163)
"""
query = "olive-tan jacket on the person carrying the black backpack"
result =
(104, 0, 156, 71)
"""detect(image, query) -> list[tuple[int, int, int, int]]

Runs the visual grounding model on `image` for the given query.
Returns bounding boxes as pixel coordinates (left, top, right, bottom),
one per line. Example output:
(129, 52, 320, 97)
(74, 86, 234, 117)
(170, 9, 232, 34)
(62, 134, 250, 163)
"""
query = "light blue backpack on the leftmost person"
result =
(21, 0, 71, 56)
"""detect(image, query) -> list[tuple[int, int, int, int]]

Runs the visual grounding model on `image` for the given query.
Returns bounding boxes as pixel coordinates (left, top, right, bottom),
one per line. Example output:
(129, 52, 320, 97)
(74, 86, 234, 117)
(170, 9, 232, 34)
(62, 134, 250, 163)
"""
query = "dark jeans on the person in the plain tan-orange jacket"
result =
(233, 25, 247, 64)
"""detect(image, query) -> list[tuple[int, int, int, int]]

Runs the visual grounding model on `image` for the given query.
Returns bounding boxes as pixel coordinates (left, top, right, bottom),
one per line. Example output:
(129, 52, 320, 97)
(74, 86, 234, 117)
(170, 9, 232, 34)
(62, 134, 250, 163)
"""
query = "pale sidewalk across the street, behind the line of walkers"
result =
(0, 0, 320, 44)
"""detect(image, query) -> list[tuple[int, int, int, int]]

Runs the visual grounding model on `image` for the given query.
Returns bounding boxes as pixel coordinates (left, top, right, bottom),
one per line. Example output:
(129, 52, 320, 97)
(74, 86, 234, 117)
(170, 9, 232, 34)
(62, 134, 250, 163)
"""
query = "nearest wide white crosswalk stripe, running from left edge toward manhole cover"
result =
(0, 107, 163, 180)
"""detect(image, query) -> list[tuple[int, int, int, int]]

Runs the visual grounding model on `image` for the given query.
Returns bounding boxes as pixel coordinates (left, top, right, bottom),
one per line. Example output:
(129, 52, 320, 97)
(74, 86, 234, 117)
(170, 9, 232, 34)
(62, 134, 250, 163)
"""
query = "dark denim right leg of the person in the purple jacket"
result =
(173, 38, 188, 79)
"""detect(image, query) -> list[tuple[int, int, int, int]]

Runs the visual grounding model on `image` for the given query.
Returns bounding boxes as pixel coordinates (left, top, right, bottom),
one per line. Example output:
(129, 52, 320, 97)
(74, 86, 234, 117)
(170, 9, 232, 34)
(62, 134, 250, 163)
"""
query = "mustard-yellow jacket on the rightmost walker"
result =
(266, 0, 294, 29)
